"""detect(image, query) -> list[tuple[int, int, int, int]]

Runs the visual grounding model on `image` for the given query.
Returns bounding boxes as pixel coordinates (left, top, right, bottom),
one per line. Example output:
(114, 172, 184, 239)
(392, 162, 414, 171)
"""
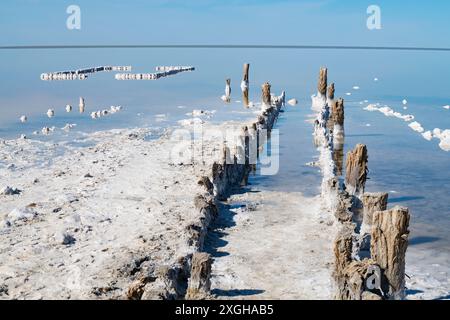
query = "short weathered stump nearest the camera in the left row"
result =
(186, 252, 212, 300)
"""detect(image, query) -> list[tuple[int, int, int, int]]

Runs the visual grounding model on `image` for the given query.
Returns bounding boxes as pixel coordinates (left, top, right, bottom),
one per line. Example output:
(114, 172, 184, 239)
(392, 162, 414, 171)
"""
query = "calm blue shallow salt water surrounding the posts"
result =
(0, 49, 450, 298)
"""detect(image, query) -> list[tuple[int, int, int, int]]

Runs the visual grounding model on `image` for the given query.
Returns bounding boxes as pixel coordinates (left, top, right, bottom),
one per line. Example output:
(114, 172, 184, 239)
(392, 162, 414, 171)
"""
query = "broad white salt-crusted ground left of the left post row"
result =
(0, 129, 209, 299)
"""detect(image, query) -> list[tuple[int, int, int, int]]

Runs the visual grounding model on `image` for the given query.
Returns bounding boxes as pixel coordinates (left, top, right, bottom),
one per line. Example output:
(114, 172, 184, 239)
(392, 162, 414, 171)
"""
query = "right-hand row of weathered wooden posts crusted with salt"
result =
(318, 68, 410, 300)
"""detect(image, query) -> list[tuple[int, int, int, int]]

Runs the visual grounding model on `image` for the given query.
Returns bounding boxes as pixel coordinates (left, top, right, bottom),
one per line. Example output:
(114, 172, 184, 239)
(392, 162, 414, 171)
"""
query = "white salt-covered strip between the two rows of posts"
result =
(207, 189, 335, 299)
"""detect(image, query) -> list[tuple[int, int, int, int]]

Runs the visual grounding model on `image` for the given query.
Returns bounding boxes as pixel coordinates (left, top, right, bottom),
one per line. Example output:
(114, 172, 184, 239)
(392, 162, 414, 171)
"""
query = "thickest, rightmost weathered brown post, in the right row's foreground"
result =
(370, 206, 410, 300)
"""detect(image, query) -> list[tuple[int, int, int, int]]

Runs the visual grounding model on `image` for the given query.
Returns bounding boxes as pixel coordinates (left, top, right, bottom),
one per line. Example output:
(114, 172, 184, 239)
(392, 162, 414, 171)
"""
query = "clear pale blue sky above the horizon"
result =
(0, 0, 450, 47)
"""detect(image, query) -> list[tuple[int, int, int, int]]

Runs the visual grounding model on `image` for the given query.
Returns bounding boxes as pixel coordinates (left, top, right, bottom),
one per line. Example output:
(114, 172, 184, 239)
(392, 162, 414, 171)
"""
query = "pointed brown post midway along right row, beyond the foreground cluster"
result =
(345, 144, 368, 196)
